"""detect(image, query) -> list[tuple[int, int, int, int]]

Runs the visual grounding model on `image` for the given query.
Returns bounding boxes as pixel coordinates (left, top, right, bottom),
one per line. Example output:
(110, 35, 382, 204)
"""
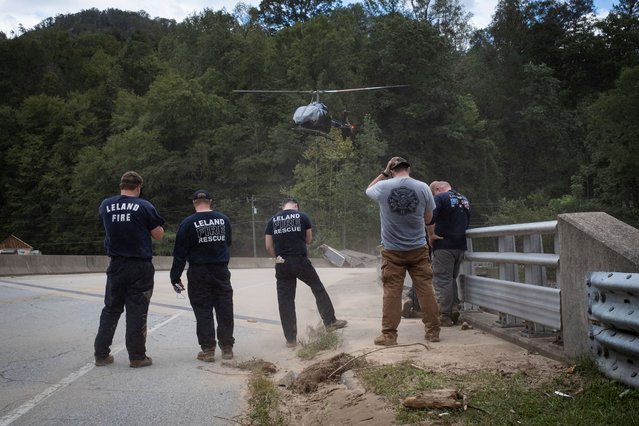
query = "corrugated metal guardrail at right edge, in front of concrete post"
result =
(586, 272, 639, 388)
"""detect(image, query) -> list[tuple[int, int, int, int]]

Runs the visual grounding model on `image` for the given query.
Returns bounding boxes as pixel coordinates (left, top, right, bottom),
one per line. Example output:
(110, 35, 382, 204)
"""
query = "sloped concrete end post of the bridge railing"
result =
(557, 212, 639, 358)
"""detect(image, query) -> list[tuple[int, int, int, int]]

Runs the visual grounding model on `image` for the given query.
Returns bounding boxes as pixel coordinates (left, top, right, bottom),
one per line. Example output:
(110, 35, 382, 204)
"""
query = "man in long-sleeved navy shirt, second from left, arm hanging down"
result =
(170, 189, 235, 362)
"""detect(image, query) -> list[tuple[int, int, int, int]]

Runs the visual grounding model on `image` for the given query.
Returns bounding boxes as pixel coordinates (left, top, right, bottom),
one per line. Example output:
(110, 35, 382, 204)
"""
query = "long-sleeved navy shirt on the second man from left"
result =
(170, 211, 232, 283)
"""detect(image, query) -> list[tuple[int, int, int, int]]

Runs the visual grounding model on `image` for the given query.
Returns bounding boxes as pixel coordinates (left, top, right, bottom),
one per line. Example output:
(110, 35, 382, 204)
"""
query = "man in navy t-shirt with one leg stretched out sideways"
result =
(264, 198, 346, 347)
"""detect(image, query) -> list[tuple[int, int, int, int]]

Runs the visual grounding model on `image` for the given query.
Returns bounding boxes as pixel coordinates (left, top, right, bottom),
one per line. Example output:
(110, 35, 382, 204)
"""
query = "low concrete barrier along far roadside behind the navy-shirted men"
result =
(0, 254, 333, 276)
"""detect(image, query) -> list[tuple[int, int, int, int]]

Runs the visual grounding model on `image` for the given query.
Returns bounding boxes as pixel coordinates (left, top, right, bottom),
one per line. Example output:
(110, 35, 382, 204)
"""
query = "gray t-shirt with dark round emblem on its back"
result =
(366, 177, 435, 251)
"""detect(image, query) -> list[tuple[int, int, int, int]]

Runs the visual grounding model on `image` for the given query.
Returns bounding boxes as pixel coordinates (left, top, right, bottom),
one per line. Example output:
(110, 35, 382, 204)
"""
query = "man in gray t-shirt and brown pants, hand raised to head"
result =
(366, 157, 439, 346)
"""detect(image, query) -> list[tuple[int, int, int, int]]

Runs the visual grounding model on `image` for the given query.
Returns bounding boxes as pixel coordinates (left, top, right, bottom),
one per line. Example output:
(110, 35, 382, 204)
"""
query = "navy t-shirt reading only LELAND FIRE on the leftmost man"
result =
(98, 195, 164, 259)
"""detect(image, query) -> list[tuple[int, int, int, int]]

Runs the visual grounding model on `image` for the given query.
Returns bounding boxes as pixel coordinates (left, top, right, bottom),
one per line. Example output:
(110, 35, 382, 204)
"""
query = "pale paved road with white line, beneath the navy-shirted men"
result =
(0, 268, 379, 426)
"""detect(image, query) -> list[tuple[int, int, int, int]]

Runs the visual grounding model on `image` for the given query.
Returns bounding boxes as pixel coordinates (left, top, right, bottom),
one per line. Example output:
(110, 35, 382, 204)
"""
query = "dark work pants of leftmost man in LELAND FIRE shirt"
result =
(94, 258, 155, 360)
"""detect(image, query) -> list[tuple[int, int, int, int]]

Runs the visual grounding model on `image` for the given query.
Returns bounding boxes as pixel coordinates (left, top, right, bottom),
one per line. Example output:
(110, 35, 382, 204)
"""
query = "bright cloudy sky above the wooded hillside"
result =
(0, 0, 618, 36)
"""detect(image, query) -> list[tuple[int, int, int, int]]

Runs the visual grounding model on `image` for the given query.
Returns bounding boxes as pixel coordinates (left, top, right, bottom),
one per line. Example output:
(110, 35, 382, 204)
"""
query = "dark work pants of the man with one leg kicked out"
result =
(275, 256, 336, 341)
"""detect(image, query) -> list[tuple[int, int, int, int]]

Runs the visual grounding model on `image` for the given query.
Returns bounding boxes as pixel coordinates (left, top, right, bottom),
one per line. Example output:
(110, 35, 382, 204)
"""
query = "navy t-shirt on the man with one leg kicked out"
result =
(264, 209, 311, 256)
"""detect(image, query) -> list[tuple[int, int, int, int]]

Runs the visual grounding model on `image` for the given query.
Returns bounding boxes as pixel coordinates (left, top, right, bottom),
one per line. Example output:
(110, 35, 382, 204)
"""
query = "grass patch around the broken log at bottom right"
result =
(357, 360, 639, 426)
